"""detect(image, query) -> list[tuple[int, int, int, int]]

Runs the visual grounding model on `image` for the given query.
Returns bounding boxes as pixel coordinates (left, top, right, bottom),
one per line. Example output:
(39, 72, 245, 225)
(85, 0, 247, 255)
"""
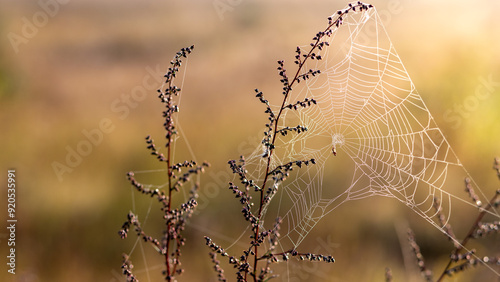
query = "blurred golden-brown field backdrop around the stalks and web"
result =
(0, 0, 500, 281)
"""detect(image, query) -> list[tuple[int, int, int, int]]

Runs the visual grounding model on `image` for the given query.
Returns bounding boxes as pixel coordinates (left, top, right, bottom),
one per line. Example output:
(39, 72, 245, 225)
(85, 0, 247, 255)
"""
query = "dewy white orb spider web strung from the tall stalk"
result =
(240, 8, 498, 250)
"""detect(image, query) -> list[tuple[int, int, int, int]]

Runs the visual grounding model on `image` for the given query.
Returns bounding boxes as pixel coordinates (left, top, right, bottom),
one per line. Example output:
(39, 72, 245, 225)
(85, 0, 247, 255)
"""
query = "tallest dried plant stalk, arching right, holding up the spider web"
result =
(205, 2, 372, 281)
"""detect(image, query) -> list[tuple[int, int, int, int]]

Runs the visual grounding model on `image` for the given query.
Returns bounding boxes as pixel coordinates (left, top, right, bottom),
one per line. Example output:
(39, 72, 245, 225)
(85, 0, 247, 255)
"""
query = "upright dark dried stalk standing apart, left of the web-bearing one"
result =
(118, 46, 209, 281)
